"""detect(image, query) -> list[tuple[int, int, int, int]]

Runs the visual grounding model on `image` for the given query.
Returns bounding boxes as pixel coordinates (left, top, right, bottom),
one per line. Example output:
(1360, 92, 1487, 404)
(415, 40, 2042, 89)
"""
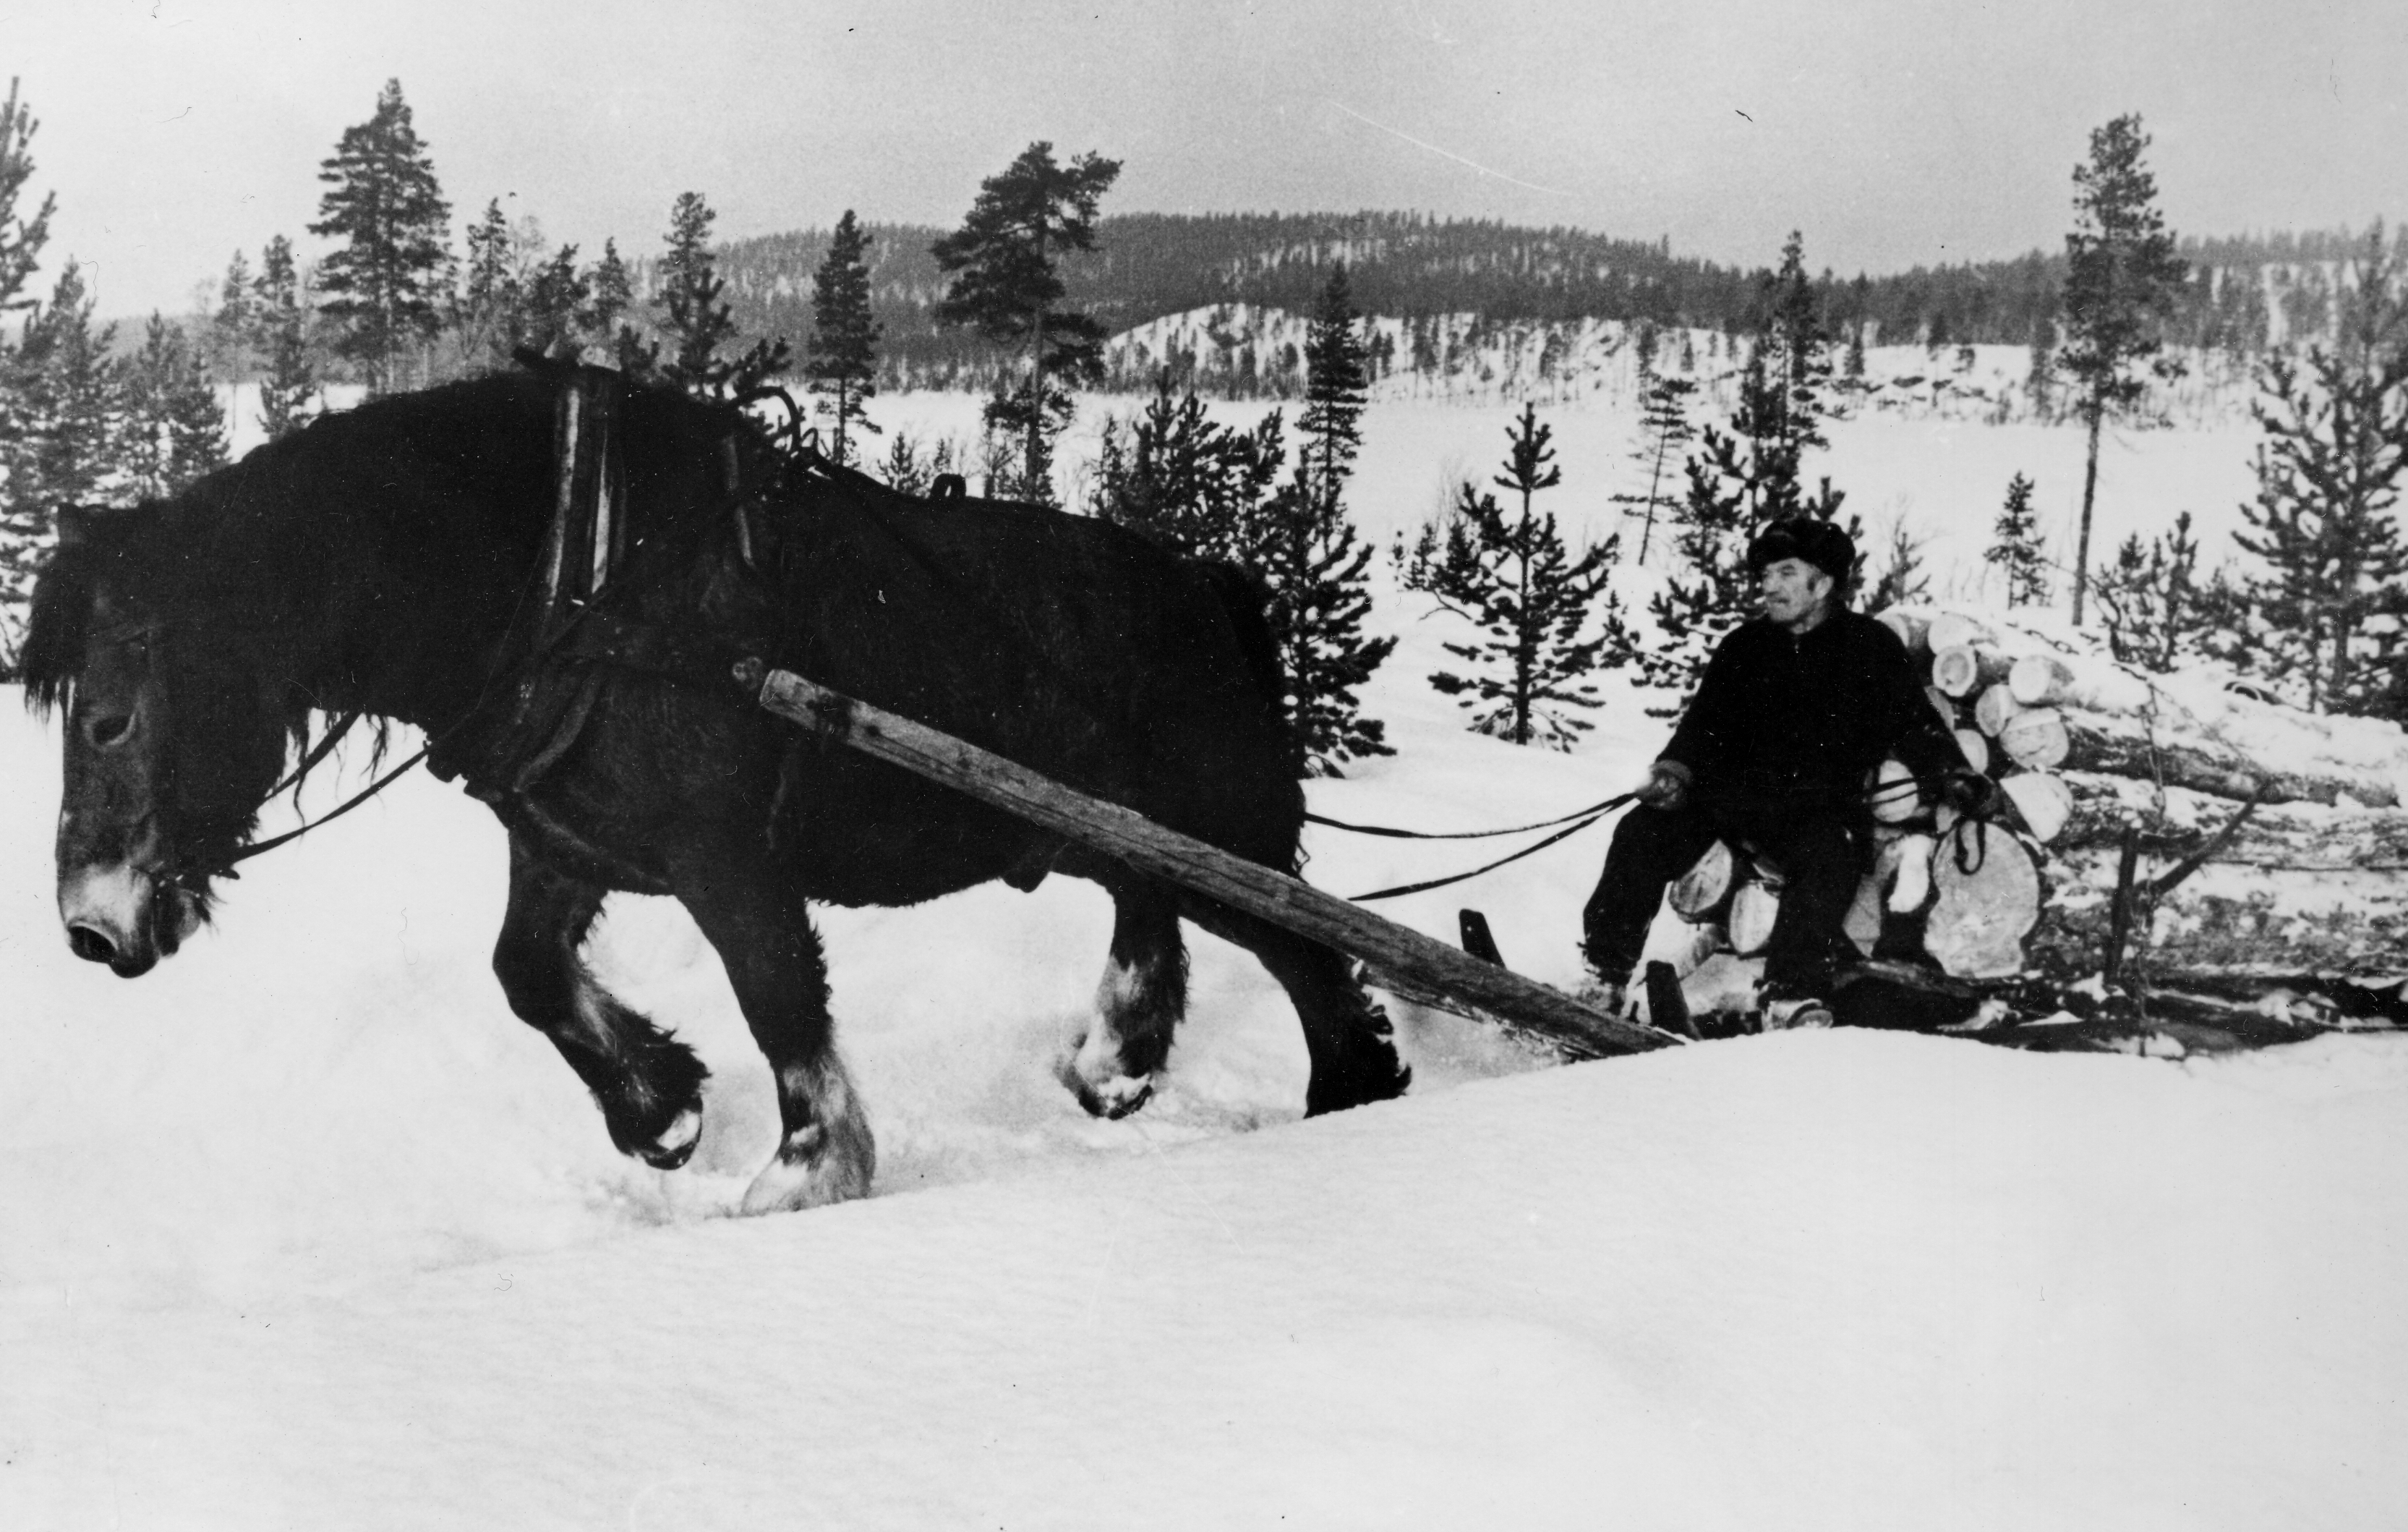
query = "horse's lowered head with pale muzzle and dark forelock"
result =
(24, 503, 291, 978)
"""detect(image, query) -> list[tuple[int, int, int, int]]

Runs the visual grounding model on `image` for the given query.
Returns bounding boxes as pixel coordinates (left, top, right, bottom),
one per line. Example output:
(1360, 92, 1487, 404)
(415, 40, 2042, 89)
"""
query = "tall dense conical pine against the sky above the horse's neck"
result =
(308, 80, 451, 393)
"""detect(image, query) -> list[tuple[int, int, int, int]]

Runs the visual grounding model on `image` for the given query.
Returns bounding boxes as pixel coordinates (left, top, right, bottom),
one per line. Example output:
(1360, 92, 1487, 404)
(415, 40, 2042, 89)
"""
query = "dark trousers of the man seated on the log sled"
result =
(1579, 804, 1871, 995)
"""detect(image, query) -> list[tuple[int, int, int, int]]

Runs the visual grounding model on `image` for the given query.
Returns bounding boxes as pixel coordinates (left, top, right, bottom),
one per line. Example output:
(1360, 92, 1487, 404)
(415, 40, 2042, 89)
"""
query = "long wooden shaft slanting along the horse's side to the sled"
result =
(761, 670, 1676, 1057)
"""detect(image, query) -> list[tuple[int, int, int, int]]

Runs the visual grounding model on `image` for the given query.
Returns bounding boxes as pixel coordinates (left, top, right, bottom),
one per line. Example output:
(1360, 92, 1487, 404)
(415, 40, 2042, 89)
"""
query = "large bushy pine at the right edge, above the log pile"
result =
(2234, 224, 2408, 710)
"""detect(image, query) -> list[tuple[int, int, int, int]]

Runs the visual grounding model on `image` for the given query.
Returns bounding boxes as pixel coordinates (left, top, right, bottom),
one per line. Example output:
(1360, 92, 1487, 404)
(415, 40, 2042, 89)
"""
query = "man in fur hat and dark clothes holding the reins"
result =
(1582, 516, 1989, 1029)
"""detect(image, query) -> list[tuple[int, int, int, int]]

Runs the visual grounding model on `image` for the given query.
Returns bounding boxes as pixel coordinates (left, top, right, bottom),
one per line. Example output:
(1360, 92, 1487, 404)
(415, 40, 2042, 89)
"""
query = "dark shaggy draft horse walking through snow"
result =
(24, 373, 1409, 1212)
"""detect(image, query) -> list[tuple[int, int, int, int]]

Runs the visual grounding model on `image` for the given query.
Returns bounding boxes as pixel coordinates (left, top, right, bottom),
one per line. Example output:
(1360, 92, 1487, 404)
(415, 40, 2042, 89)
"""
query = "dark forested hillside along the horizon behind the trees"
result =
(683, 212, 2350, 393)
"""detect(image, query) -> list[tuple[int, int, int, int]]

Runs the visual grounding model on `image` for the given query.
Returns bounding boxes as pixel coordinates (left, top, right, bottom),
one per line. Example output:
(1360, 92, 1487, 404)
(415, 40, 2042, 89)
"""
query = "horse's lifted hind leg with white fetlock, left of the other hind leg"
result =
(1062, 877, 1187, 1118)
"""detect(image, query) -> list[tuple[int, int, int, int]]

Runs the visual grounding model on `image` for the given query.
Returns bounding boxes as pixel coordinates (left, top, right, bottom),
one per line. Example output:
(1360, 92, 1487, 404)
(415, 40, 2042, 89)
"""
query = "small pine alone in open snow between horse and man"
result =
(1404, 404, 1626, 749)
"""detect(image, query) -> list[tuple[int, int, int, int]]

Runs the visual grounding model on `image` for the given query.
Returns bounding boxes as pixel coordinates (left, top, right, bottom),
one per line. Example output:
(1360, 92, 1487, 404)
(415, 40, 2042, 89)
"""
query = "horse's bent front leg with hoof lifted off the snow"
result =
(494, 836, 708, 1170)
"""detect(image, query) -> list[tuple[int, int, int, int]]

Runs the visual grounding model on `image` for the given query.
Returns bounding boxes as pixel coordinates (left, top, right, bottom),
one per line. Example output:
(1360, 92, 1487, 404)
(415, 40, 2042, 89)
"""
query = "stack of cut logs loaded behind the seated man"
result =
(1671, 597, 2408, 978)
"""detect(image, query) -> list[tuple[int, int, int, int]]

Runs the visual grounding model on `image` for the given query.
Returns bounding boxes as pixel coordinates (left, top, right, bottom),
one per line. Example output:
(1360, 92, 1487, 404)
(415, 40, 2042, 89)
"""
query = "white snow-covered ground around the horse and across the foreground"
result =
(0, 385, 2408, 1530)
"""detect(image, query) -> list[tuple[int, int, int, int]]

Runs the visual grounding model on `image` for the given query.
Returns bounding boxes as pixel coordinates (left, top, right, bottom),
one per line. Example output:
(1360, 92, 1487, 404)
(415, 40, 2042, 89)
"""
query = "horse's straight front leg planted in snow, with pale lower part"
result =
(670, 836, 876, 1214)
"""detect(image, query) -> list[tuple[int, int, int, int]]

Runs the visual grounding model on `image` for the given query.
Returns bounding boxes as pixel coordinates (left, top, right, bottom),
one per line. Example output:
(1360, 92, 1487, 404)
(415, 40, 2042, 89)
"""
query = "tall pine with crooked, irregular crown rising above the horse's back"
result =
(929, 142, 1119, 503)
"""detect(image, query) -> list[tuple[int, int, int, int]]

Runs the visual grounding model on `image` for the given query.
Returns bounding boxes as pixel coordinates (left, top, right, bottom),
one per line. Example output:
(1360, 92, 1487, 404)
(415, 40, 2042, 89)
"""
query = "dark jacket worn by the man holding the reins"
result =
(1662, 610, 1965, 819)
